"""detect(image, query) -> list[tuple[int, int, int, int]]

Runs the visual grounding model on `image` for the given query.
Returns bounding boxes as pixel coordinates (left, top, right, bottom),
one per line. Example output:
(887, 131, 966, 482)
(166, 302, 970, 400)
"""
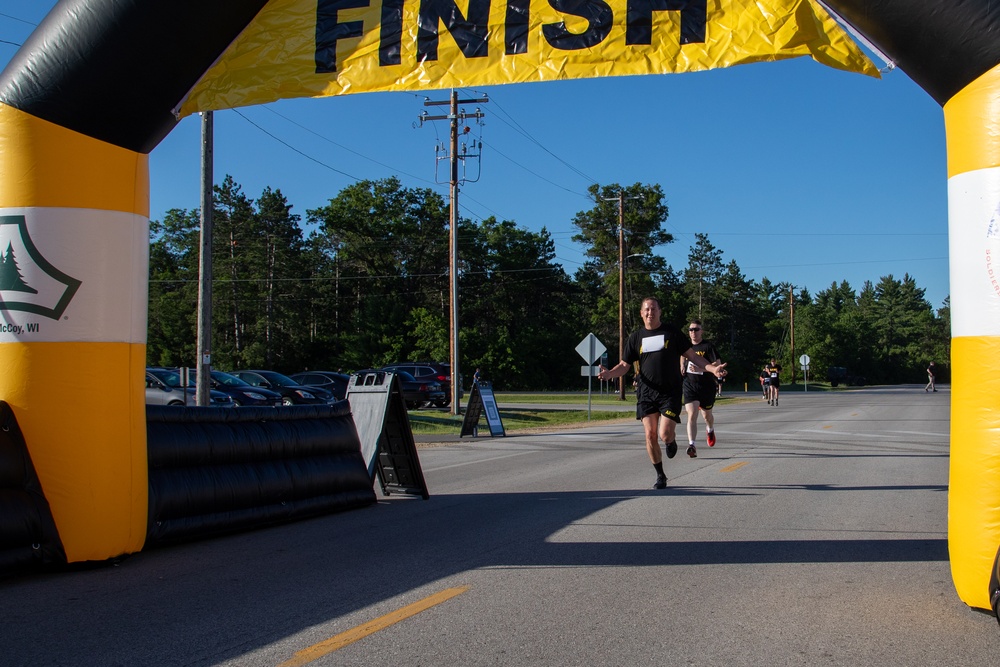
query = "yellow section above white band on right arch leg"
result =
(944, 65, 1000, 178)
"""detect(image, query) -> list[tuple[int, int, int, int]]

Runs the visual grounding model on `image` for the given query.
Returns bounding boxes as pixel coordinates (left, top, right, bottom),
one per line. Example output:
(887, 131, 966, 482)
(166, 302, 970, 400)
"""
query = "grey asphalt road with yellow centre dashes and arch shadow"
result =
(0, 387, 1000, 667)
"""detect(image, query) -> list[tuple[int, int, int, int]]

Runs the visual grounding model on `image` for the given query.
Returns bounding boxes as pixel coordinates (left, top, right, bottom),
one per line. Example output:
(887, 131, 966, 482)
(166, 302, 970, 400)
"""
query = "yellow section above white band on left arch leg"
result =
(0, 104, 149, 218)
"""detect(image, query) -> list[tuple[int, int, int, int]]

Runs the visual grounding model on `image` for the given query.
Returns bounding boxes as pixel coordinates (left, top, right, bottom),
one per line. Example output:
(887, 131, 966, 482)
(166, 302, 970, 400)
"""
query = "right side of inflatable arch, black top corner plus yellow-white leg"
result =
(829, 0, 1000, 609)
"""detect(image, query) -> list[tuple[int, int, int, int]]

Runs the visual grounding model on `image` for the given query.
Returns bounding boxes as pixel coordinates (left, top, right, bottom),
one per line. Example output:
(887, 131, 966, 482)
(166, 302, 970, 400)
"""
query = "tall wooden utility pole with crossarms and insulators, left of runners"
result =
(420, 90, 490, 415)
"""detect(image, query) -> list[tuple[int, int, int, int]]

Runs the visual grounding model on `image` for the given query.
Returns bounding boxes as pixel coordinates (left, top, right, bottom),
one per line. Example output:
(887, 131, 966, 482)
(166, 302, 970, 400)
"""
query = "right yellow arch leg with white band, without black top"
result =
(944, 68, 1000, 609)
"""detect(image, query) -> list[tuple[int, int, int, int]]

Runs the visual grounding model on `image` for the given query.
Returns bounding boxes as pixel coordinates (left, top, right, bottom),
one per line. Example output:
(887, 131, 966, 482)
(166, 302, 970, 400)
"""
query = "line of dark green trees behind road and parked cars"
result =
(147, 176, 950, 390)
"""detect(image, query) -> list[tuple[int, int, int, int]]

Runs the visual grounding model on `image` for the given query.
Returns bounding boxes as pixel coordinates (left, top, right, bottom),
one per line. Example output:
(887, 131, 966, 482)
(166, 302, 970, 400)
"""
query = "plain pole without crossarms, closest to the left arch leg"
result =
(195, 111, 215, 405)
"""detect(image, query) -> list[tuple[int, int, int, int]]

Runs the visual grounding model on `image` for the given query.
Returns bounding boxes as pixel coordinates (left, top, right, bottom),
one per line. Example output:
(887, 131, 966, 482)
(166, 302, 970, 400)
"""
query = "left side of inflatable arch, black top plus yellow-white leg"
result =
(0, 0, 266, 562)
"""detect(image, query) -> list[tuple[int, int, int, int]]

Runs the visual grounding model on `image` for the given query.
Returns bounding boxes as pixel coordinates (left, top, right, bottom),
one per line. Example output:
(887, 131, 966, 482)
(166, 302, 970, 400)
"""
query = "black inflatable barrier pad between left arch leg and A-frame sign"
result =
(146, 401, 376, 546)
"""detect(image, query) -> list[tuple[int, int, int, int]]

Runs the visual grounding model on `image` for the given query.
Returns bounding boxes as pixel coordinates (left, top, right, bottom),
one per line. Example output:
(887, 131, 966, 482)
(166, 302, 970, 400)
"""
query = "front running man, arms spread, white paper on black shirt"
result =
(597, 297, 726, 489)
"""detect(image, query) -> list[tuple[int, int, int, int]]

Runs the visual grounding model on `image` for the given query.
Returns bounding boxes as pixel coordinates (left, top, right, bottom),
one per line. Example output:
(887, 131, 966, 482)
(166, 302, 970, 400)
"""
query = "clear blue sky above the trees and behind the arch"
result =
(0, 0, 949, 308)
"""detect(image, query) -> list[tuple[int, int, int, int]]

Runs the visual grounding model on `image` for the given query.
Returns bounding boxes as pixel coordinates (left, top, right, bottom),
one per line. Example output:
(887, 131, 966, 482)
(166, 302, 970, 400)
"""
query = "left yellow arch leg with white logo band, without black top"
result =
(0, 105, 149, 562)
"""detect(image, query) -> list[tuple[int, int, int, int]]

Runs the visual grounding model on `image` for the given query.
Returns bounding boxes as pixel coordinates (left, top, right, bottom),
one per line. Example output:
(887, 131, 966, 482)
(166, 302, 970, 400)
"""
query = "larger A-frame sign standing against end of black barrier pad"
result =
(347, 372, 430, 500)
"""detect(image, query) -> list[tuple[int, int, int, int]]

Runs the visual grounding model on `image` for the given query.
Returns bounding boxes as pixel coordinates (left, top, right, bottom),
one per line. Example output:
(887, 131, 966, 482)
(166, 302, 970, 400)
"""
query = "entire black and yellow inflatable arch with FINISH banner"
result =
(0, 0, 1000, 608)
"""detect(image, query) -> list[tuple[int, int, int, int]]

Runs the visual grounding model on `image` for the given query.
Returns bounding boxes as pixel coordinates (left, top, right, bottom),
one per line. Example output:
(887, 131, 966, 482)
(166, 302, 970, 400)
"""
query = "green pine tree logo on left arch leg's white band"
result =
(0, 215, 81, 320)
